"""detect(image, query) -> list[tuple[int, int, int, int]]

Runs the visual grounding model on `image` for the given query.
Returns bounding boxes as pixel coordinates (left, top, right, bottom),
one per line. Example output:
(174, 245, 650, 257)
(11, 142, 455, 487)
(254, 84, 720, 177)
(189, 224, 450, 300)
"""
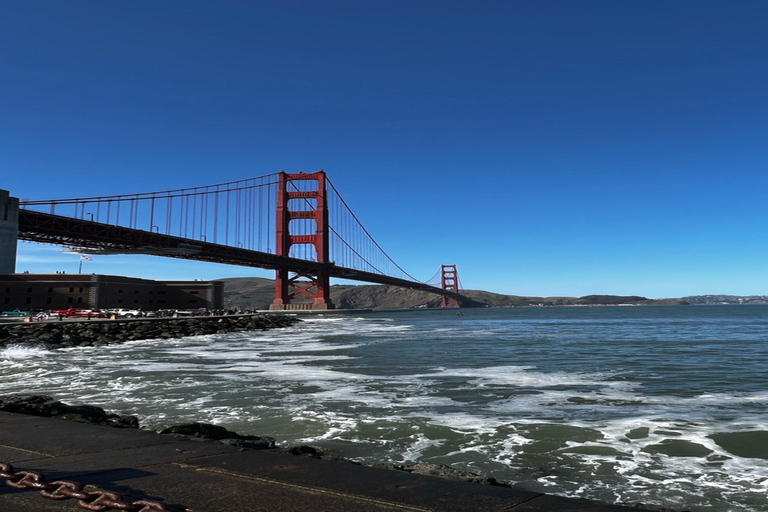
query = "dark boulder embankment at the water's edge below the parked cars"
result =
(0, 314, 301, 348)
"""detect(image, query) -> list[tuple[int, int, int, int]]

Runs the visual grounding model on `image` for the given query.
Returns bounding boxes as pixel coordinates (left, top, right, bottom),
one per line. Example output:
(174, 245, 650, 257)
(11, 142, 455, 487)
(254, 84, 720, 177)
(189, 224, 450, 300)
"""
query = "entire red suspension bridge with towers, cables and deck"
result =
(12, 171, 464, 310)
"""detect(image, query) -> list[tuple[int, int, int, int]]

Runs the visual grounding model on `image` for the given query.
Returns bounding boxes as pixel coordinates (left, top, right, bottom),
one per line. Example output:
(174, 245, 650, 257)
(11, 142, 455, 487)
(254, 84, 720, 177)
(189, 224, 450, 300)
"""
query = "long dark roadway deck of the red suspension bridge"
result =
(19, 209, 461, 298)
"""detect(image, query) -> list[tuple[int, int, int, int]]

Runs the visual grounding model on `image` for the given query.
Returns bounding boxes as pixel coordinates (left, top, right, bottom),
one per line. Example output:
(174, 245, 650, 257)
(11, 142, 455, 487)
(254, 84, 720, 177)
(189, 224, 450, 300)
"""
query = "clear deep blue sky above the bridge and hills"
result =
(0, 0, 768, 298)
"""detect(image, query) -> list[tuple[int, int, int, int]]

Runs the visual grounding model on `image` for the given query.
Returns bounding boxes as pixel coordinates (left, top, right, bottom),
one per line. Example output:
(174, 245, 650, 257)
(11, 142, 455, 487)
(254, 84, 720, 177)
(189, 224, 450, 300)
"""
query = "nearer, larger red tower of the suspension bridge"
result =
(269, 171, 334, 310)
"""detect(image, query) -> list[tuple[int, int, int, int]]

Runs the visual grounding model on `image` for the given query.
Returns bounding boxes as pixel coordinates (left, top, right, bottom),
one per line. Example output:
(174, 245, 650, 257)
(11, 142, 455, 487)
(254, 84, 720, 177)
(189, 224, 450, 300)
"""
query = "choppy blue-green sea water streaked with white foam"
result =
(0, 306, 768, 512)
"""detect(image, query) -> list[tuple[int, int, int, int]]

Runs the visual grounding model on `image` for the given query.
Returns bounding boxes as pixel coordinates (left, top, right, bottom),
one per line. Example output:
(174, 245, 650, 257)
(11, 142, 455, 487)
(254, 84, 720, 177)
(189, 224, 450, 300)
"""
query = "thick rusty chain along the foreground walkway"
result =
(0, 462, 169, 512)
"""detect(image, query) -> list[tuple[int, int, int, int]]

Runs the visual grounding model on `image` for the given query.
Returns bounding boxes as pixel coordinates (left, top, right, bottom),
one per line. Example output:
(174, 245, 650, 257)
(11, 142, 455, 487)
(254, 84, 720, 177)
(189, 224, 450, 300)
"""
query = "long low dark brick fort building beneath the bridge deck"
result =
(0, 273, 224, 311)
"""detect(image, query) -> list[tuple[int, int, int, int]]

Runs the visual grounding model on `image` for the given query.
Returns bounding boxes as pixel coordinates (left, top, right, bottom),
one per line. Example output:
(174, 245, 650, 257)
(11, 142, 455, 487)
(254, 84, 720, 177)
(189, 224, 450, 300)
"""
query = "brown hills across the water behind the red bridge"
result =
(220, 277, 687, 309)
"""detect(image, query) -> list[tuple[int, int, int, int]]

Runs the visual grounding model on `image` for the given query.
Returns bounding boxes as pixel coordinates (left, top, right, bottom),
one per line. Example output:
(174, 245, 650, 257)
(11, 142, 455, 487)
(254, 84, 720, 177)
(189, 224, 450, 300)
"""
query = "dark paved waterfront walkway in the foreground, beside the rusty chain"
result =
(0, 411, 656, 512)
